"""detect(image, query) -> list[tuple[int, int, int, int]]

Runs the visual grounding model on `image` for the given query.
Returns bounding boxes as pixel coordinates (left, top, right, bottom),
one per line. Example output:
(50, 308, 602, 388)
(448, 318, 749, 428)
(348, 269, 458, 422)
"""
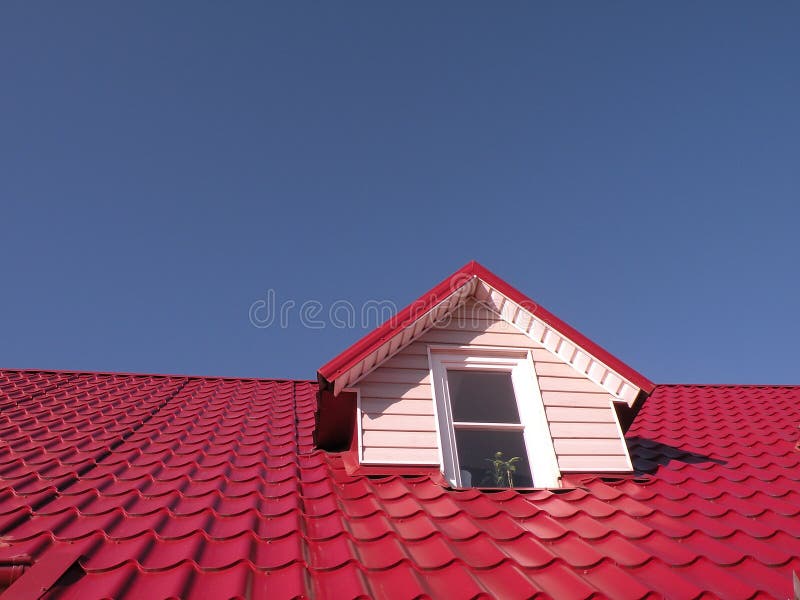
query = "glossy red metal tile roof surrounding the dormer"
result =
(0, 371, 800, 600)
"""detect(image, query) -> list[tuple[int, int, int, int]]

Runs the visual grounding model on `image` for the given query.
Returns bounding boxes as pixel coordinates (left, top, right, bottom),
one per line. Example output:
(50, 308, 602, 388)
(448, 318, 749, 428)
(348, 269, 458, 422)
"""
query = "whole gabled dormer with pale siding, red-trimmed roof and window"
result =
(316, 262, 654, 488)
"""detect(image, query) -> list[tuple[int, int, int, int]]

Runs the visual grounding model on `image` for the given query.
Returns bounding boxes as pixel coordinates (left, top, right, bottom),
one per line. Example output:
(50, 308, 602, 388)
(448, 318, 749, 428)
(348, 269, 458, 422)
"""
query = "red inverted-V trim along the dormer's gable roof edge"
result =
(317, 260, 655, 394)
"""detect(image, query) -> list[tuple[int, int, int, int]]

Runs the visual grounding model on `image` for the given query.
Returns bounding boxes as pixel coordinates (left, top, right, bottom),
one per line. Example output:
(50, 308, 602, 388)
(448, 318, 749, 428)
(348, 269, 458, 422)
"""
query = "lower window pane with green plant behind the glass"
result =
(456, 429, 533, 487)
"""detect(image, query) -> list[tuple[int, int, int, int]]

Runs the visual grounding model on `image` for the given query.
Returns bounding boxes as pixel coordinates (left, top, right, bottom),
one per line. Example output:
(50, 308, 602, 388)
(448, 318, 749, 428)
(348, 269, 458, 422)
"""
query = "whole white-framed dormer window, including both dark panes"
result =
(429, 346, 559, 487)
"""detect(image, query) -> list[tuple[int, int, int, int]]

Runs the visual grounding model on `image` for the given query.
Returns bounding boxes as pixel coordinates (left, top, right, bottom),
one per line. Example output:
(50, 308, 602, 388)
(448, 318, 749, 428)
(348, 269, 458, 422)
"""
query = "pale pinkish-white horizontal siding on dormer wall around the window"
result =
(357, 300, 630, 471)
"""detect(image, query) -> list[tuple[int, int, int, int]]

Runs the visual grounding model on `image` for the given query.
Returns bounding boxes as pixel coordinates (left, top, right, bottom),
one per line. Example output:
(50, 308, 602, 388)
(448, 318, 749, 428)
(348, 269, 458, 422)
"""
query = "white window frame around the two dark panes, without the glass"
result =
(428, 346, 561, 488)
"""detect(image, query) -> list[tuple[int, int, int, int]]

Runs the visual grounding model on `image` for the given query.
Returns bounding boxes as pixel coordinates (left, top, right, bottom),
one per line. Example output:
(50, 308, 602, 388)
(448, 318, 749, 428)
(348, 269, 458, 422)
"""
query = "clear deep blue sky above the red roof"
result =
(0, 2, 800, 383)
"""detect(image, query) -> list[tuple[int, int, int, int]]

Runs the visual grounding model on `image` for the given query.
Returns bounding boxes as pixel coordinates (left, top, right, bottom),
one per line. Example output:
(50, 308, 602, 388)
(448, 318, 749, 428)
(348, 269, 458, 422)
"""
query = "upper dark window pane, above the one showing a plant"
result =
(447, 371, 519, 423)
